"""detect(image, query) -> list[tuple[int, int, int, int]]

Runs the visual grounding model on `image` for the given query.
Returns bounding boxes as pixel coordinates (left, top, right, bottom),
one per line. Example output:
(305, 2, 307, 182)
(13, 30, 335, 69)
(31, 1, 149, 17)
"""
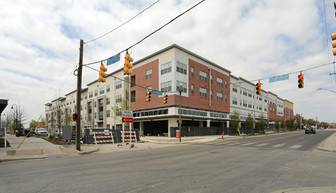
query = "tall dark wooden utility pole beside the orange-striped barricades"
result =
(76, 40, 84, 151)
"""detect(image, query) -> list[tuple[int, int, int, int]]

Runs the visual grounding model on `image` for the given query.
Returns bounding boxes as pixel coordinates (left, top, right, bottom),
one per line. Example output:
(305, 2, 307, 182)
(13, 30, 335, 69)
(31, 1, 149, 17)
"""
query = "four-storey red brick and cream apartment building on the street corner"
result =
(45, 44, 293, 136)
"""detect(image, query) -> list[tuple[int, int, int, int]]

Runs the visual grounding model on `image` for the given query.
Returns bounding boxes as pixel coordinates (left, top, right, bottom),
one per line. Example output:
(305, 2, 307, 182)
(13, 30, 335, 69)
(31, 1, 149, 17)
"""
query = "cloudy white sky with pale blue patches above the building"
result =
(0, 0, 336, 126)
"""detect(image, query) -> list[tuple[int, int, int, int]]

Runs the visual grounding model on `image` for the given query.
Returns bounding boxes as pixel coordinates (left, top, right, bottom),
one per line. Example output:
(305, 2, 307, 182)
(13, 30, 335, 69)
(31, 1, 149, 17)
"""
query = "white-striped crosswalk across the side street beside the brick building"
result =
(203, 140, 302, 150)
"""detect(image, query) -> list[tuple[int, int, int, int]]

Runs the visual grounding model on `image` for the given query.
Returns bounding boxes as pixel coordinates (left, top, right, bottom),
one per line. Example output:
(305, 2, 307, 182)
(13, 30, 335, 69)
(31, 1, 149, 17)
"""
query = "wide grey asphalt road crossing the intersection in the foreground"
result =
(0, 131, 336, 193)
